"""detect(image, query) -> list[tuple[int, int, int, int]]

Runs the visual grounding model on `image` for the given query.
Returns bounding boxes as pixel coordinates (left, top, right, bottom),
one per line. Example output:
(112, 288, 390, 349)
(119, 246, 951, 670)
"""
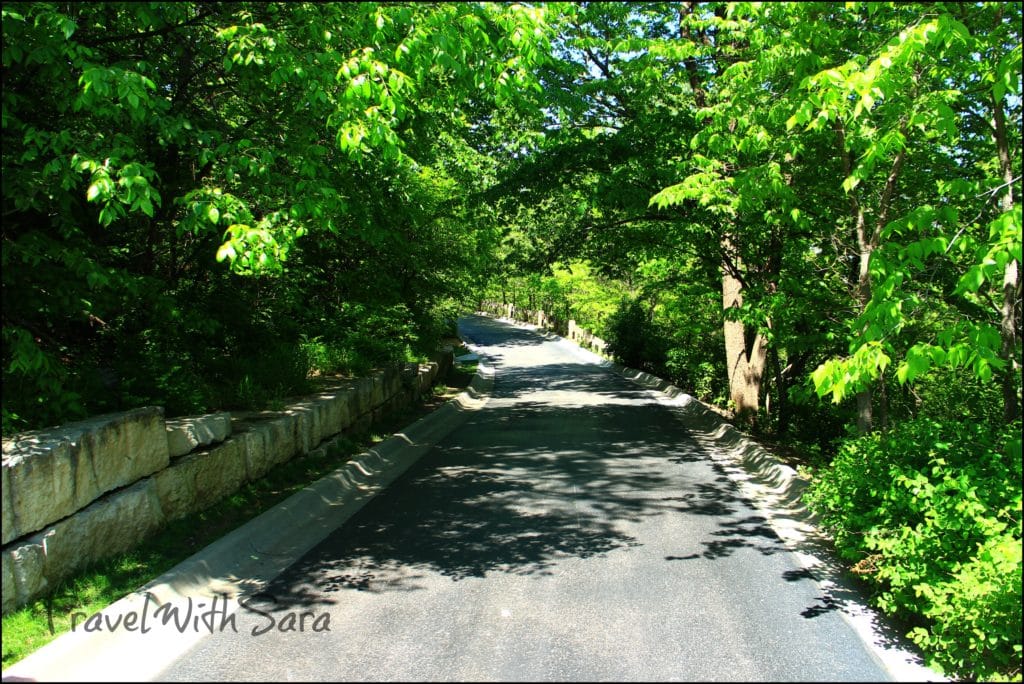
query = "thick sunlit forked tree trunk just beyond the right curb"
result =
(722, 267, 768, 423)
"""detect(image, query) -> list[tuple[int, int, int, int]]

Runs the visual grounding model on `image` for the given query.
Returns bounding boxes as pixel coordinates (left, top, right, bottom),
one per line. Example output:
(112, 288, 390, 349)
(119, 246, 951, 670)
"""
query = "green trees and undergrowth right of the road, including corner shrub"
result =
(488, 2, 1021, 679)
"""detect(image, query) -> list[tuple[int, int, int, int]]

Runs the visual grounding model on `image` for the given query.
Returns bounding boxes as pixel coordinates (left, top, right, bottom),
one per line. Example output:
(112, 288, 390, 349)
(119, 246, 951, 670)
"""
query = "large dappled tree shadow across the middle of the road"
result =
(256, 348, 798, 609)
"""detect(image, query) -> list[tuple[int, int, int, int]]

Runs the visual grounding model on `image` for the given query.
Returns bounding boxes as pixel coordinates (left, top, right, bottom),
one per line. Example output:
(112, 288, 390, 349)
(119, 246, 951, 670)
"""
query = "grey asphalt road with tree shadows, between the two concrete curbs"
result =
(155, 317, 889, 681)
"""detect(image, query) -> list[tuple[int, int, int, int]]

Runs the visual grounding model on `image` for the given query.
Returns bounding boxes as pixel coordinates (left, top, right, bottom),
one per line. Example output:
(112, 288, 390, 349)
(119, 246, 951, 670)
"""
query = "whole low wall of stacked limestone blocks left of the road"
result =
(2, 352, 452, 614)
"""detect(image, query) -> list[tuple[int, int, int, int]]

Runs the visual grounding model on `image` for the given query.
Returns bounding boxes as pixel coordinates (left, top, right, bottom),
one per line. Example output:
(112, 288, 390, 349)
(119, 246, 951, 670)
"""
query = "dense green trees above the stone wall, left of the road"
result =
(3, 3, 546, 432)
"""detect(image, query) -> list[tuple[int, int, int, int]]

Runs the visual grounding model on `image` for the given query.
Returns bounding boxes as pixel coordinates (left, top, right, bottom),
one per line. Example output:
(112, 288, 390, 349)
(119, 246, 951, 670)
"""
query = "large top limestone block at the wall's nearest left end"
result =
(3, 407, 170, 544)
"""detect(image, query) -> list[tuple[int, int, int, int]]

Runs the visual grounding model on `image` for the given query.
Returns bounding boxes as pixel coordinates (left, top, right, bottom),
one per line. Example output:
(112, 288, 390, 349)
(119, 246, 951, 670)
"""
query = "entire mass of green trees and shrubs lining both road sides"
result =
(3, 2, 1022, 679)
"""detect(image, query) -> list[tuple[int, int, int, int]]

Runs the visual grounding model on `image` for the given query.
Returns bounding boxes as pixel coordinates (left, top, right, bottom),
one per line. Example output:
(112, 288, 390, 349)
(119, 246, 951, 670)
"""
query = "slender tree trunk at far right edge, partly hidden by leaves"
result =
(992, 90, 1021, 423)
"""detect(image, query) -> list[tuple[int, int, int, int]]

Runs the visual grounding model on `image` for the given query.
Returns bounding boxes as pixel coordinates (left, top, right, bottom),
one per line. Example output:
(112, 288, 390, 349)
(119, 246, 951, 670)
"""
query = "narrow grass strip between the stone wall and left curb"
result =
(2, 358, 476, 668)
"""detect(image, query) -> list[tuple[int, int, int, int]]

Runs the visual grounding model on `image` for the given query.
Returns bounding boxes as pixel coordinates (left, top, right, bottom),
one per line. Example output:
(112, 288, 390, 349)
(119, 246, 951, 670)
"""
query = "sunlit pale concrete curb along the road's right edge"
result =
(477, 311, 949, 682)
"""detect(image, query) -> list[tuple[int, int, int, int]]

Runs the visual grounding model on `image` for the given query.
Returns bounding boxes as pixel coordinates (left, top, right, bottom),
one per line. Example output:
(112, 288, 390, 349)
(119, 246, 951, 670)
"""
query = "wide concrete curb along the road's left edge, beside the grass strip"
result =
(2, 356, 494, 682)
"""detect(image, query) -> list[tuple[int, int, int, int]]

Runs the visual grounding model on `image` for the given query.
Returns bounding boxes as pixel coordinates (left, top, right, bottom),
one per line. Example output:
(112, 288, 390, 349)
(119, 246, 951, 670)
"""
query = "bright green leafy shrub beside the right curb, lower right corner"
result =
(807, 419, 1021, 680)
